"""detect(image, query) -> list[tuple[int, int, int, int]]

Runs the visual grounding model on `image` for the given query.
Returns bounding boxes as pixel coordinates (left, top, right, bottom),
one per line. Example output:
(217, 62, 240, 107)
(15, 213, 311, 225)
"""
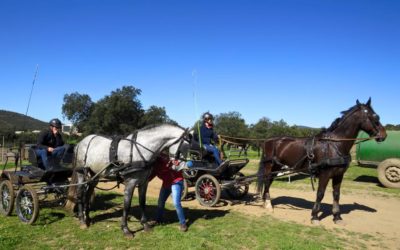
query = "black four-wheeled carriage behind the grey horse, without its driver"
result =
(0, 145, 73, 224)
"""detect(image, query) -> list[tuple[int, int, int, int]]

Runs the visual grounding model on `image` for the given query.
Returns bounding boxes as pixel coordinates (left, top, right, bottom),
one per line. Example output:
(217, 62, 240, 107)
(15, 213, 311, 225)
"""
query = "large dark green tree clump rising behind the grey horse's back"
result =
(62, 86, 176, 135)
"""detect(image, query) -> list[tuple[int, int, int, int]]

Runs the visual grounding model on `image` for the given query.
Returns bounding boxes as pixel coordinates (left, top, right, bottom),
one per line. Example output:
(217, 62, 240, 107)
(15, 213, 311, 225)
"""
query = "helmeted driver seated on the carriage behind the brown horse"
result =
(194, 112, 222, 166)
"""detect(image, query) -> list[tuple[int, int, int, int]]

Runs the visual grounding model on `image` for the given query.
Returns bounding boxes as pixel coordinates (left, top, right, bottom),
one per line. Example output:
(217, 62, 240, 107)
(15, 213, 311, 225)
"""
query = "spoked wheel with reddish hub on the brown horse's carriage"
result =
(196, 174, 221, 207)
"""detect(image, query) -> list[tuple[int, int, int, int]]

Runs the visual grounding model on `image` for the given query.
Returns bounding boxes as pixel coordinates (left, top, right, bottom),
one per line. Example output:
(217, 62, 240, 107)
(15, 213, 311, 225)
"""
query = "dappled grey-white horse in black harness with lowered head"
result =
(68, 124, 191, 238)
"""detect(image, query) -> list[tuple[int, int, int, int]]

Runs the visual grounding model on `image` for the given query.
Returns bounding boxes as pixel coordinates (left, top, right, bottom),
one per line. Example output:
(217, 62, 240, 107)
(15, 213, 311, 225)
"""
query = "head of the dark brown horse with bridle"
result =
(357, 98, 387, 142)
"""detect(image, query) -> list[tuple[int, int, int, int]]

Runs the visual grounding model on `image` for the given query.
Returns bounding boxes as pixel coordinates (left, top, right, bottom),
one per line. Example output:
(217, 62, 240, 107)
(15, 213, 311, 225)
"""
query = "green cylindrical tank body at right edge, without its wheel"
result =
(356, 131, 400, 165)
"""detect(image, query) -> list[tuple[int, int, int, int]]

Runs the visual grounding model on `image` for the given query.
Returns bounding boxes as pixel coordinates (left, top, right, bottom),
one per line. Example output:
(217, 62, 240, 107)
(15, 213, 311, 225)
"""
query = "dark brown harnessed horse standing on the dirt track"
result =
(257, 98, 386, 224)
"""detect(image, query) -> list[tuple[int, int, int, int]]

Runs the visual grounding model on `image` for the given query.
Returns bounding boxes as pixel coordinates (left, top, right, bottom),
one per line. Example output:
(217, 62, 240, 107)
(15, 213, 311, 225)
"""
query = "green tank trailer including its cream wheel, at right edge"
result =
(356, 131, 400, 188)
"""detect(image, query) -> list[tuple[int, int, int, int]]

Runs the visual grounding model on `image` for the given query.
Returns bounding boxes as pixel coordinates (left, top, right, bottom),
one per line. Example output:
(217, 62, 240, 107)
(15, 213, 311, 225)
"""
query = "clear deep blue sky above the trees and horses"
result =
(0, 0, 400, 127)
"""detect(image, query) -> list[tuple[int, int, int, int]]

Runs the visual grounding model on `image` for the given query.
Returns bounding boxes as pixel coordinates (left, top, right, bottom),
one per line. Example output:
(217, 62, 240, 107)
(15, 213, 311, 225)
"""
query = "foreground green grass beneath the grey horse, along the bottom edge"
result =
(0, 193, 377, 249)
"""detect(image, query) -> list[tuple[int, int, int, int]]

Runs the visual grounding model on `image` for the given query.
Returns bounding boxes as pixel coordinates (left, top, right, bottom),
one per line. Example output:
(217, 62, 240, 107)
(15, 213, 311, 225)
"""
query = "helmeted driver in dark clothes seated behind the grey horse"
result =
(36, 118, 65, 170)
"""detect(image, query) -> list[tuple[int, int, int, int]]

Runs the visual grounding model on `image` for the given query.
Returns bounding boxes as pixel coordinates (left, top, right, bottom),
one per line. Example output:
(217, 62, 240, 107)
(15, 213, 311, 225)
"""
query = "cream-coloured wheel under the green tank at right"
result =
(378, 158, 400, 188)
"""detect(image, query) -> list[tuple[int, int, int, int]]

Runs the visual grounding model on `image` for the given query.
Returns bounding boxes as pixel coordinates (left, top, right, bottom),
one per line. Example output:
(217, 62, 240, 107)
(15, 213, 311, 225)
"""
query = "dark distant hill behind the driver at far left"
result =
(0, 110, 47, 131)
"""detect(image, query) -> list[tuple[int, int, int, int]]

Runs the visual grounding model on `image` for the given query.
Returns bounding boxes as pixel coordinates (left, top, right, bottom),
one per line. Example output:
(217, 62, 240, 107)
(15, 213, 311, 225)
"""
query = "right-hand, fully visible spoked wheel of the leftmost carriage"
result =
(15, 186, 39, 224)
